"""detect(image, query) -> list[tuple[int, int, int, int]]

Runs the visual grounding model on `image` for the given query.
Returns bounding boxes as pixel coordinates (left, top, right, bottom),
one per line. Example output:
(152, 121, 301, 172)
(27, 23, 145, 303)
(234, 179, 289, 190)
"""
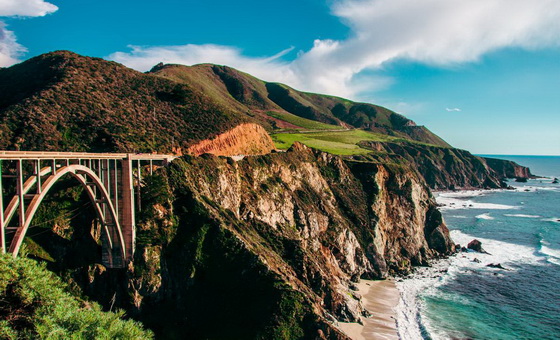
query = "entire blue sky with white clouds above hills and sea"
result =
(0, 0, 560, 155)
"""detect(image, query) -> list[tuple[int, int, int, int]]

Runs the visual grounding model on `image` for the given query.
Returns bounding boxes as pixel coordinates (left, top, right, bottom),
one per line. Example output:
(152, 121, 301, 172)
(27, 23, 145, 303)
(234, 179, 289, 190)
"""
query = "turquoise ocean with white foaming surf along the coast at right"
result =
(397, 156, 560, 340)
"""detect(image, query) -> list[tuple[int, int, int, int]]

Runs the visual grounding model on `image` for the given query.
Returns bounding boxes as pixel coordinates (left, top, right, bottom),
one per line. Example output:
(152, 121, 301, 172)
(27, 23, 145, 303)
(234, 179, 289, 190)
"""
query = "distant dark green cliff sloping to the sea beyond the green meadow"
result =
(357, 142, 531, 190)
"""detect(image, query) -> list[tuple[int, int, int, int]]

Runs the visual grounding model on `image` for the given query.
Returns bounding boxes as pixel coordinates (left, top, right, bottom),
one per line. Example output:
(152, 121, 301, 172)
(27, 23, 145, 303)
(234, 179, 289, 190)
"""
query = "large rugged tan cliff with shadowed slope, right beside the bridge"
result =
(115, 144, 453, 338)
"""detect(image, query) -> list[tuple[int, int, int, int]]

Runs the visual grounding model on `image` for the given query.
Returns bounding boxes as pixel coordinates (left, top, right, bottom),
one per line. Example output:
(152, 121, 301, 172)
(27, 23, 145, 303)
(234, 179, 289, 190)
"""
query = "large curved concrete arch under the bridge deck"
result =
(7, 164, 127, 261)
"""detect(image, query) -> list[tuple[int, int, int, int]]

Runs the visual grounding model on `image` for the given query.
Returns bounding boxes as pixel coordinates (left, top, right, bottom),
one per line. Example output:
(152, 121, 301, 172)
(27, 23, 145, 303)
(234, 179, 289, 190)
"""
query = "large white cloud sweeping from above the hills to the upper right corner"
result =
(108, 0, 560, 98)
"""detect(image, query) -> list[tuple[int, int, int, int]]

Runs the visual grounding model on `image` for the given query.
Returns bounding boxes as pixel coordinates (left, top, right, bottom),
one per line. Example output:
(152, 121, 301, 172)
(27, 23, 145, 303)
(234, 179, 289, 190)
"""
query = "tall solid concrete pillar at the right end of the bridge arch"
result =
(119, 154, 136, 261)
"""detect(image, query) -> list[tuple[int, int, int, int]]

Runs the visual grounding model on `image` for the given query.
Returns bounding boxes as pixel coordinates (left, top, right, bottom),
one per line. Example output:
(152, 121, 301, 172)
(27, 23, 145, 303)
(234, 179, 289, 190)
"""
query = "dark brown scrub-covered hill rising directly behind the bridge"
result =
(0, 51, 254, 152)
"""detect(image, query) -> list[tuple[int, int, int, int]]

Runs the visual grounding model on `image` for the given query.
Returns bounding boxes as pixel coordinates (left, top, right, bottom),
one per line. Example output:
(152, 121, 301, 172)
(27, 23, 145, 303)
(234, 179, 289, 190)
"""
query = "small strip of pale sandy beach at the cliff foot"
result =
(339, 280, 399, 340)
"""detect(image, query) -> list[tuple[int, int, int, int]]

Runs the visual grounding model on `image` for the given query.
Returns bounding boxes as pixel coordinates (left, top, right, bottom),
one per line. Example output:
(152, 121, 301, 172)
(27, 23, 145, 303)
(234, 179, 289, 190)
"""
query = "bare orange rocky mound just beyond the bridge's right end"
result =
(188, 123, 274, 156)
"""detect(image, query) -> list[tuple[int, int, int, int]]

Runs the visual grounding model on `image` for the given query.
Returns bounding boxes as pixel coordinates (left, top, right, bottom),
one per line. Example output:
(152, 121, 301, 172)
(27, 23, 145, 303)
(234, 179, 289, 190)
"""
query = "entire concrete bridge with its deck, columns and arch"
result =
(0, 151, 177, 268)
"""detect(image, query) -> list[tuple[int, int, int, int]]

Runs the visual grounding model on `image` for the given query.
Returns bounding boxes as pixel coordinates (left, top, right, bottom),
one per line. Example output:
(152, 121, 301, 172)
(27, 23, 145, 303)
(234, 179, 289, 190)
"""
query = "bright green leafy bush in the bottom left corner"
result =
(0, 255, 152, 339)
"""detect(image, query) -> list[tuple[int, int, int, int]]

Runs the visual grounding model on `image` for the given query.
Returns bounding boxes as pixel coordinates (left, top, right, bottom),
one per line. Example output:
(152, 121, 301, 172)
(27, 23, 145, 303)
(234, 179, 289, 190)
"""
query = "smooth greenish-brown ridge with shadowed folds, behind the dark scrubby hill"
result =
(150, 64, 449, 147)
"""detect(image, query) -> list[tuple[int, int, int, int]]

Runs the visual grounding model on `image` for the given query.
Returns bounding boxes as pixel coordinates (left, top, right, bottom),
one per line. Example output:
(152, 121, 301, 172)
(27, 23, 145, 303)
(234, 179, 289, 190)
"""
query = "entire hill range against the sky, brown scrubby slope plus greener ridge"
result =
(0, 51, 448, 154)
